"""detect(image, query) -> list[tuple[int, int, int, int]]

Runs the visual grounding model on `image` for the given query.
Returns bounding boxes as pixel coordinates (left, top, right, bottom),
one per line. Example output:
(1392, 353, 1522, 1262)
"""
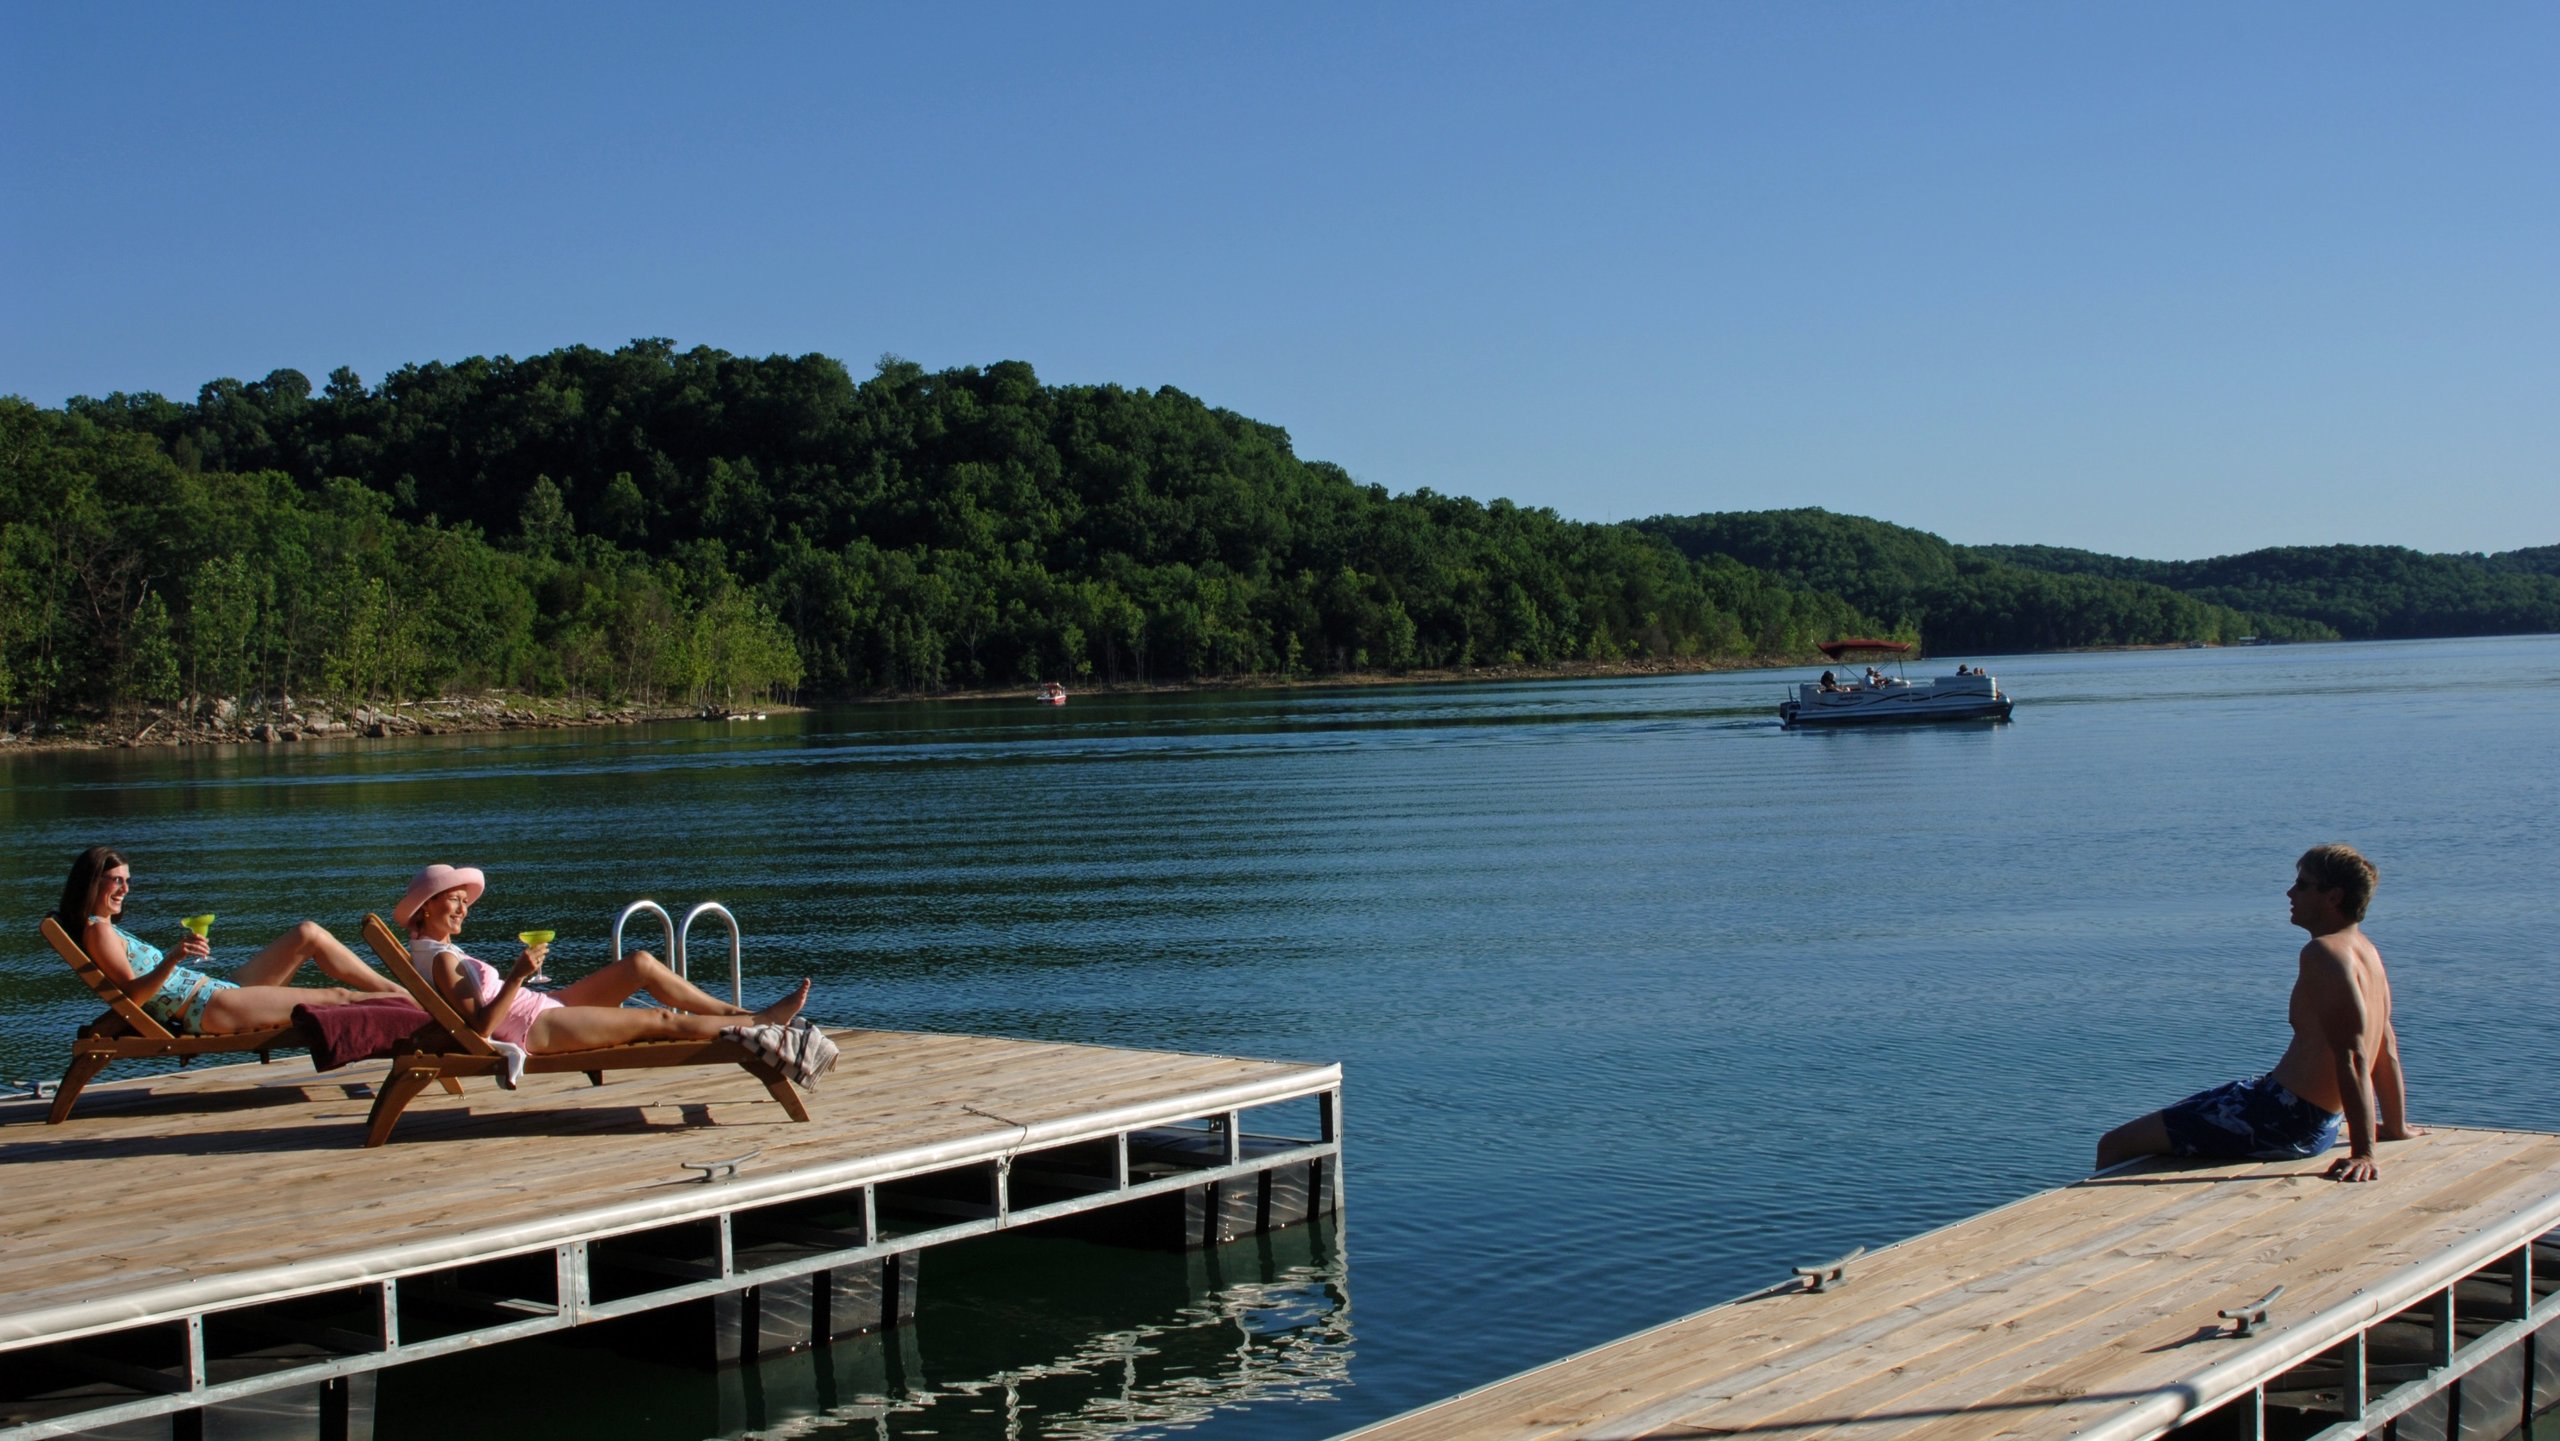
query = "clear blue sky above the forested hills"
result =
(0, 0, 2560, 558)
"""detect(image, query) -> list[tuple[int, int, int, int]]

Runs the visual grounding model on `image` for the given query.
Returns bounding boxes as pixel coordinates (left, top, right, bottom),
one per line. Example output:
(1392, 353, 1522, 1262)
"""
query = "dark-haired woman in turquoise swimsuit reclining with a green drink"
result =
(54, 845, 407, 1037)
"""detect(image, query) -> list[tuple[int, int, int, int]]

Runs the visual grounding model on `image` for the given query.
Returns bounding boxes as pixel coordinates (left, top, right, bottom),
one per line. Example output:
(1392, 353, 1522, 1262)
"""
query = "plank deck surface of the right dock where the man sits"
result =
(1357, 1129, 2560, 1441)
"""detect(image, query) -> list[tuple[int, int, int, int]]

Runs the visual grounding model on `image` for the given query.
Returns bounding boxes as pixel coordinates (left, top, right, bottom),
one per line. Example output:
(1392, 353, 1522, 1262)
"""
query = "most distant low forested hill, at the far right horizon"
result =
(1971, 545, 2560, 640)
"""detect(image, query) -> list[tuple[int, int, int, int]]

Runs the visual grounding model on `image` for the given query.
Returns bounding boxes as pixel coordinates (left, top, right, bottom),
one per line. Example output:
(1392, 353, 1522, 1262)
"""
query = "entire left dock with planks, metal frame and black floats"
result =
(0, 1031, 1341, 1441)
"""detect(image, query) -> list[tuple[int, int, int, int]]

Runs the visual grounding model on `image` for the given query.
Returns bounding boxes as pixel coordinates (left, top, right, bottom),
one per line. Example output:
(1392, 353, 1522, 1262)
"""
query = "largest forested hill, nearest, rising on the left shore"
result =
(0, 340, 1871, 717)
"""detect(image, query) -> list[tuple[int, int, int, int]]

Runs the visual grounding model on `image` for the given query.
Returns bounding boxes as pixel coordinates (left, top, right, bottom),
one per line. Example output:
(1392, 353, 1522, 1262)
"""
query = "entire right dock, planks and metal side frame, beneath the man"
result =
(1349, 1129, 2560, 1441)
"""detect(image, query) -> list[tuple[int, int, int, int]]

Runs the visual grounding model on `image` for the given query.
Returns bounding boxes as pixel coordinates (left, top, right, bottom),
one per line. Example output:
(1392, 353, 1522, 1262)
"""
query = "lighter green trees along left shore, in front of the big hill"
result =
(0, 397, 801, 722)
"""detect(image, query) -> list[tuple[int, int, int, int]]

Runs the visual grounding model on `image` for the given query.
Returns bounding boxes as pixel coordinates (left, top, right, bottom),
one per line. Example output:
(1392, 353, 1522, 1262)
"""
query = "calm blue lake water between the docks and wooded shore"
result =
(0, 637, 2560, 1438)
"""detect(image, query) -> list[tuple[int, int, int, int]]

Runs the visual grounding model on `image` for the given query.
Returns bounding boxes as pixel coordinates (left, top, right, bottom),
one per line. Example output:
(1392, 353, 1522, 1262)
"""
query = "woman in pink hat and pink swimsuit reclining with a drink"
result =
(392, 865, 809, 1055)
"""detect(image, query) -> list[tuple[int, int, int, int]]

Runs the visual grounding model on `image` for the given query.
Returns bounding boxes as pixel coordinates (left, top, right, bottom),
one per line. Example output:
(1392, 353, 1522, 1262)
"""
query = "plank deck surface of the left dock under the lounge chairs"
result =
(0, 1031, 1339, 1346)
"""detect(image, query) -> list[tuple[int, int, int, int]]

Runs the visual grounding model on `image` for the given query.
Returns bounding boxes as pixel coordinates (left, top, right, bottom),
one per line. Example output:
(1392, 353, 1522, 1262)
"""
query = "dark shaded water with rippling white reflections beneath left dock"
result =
(717, 1223, 1352, 1441)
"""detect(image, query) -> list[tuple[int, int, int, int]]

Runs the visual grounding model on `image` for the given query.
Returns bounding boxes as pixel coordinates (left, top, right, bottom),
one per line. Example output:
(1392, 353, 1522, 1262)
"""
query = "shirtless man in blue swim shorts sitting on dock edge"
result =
(2097, 845, 2424, 1180)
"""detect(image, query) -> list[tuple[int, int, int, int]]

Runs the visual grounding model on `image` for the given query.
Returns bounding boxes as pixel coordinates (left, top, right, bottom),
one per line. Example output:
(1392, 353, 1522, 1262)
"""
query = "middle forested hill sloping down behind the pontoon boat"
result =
(1636, 509, 2337, 655)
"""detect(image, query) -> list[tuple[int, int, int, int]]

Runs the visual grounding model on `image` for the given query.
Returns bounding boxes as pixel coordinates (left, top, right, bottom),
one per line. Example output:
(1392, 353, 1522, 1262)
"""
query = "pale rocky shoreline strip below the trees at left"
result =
(0, 694, 794, 750)
